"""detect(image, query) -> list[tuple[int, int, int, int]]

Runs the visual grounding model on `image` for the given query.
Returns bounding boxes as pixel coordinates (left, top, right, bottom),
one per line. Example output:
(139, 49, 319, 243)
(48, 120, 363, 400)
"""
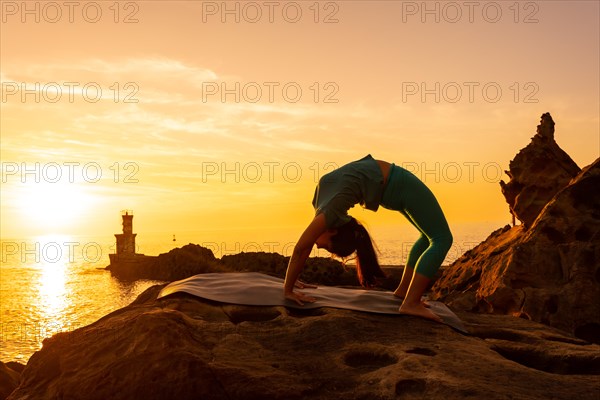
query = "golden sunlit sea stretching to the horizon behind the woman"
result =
(0, 223, 502, 364)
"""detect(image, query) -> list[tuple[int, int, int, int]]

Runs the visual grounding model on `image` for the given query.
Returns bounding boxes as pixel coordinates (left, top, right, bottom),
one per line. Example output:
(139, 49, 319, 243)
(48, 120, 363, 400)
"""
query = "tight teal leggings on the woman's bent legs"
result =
(381, 164, 452, 278)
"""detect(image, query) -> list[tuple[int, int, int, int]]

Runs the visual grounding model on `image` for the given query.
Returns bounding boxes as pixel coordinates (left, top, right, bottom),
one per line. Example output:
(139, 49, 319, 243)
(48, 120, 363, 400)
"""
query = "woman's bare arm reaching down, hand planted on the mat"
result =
(283, 213, 327, 305)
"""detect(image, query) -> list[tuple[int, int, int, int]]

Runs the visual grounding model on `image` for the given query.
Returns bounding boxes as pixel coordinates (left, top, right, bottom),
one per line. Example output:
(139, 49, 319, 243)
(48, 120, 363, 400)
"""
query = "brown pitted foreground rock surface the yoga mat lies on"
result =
(9, 286, 600, 400)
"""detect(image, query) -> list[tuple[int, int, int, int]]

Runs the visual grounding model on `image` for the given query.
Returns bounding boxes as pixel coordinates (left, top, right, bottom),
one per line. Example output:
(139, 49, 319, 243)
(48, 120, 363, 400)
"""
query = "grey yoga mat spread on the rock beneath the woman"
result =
(157, 272, 468, 333)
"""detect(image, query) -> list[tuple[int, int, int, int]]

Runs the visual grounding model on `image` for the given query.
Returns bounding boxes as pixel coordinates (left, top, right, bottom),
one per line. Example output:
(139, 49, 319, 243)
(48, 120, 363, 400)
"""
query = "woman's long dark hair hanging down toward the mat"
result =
(331, 218, 385, 287)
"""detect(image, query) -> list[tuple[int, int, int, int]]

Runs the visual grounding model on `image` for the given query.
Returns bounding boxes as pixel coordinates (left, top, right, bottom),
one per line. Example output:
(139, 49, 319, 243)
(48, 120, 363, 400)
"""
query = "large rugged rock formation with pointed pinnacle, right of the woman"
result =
(432, 114, 600, 342)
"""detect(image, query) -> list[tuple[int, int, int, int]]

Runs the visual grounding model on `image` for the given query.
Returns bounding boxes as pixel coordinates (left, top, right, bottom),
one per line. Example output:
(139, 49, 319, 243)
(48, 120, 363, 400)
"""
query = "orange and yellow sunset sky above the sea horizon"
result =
(0, 1, 600, 238)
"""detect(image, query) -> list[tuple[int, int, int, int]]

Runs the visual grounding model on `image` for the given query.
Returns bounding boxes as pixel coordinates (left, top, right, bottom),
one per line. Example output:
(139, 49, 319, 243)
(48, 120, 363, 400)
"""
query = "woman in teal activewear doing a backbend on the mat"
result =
(284, 154, 452, 321)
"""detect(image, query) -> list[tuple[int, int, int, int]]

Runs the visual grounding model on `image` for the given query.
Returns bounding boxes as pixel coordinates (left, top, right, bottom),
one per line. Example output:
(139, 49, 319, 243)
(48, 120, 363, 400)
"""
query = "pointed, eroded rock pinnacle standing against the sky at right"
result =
(500, 113, 580, 227)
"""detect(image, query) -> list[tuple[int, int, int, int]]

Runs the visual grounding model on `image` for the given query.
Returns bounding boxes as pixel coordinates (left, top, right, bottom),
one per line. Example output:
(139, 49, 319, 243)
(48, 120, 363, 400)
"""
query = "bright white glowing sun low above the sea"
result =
(18, 182, 93, 232)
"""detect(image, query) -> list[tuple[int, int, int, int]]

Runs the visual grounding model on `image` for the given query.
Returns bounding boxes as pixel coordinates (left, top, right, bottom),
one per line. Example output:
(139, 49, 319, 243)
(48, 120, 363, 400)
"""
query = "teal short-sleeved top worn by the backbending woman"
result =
(312, 154, 384, 229)
